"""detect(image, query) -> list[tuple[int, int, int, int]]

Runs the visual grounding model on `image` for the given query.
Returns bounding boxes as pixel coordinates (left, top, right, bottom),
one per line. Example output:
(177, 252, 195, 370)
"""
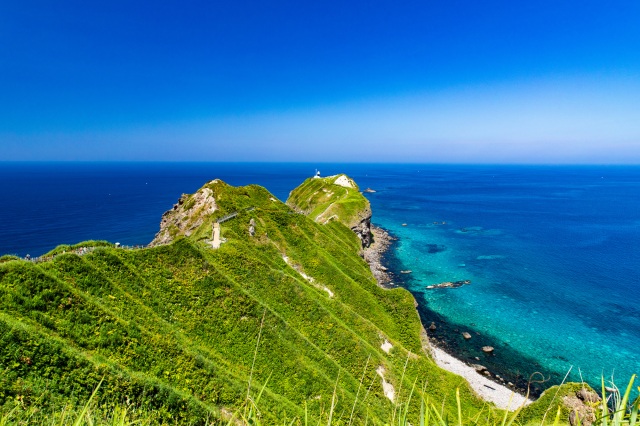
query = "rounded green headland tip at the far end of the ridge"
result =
(287, 174, 371, 247)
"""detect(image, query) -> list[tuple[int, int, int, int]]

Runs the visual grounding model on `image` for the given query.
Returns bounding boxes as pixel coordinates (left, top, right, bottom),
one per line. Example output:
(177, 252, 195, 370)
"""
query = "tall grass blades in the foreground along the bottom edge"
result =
(0, 375, 640, 426)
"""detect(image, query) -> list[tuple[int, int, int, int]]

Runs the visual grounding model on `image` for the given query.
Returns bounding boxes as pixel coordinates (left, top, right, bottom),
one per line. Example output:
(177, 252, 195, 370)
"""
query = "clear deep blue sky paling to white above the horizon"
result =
(0, 0, 640, 164)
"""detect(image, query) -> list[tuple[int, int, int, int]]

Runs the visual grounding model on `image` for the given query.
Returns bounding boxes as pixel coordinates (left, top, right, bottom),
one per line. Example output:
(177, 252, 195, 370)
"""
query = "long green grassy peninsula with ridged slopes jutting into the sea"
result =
(0, 175, 632, 424)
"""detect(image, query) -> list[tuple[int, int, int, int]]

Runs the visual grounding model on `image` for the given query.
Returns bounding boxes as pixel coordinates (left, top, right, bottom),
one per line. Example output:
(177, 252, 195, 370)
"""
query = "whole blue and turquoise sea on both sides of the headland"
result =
(0, 163, 640, 389)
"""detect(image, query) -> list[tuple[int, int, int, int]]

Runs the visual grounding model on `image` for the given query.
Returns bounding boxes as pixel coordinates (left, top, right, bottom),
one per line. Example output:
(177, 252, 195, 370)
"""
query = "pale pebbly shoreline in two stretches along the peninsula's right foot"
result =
(363, 225, 533, 411)
